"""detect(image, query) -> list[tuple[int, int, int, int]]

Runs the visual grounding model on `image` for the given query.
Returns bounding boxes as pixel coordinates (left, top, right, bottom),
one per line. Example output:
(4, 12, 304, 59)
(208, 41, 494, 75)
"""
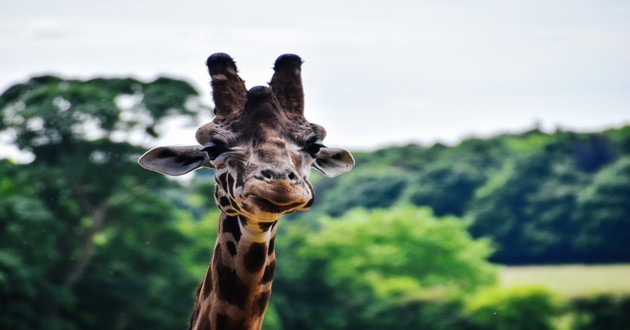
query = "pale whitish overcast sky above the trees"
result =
(0, 0, 630, 149)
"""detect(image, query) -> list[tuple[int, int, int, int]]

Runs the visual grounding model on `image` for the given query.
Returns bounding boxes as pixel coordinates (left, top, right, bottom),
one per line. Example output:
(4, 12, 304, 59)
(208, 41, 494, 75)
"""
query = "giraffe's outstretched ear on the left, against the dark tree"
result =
(138, 146, 210, 176)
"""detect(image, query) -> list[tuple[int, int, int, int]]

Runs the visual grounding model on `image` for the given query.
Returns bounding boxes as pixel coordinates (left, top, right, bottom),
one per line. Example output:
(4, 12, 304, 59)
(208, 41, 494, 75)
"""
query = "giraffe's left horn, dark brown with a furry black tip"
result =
(206, 53, 247, 117)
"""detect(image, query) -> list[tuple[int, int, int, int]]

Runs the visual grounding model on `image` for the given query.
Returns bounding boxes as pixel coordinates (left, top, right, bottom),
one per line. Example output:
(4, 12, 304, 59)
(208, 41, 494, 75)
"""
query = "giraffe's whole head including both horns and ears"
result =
(139, 53, 354, 222)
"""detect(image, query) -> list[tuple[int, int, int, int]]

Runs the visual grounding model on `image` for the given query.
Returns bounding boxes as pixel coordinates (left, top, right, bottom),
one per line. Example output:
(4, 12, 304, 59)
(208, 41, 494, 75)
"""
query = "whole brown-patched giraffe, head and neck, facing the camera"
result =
(139, 53, 354, 330)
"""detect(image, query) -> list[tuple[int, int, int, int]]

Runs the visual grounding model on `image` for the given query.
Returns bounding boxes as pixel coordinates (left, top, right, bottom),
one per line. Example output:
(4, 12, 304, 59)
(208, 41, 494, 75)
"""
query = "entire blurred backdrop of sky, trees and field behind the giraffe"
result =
(0, 0, 630, 330)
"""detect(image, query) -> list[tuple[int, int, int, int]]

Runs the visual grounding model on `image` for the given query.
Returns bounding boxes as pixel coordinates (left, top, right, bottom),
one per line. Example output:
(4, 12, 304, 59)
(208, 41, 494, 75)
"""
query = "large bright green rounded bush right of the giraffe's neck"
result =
(272, 206, 495, 329)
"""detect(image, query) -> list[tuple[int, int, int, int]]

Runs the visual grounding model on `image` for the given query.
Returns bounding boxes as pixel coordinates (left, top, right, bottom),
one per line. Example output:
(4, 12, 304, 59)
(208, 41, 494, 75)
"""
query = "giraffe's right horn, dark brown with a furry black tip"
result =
(269, 54, 304, 116)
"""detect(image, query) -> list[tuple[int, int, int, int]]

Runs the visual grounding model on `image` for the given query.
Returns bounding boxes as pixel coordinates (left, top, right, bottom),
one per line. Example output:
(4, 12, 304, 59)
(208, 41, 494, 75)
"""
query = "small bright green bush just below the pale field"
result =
(467, 287, 559, 330)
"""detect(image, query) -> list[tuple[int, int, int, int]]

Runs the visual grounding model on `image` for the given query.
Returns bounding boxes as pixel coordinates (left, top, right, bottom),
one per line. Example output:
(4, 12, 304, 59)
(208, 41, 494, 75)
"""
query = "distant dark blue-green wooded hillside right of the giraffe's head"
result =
(299, 126, 630, 264)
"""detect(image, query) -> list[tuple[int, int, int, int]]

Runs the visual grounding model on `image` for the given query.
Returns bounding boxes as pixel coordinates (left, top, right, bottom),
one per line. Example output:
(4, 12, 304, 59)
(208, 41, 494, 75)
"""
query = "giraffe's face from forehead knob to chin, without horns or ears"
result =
(197, 87, 326, 221)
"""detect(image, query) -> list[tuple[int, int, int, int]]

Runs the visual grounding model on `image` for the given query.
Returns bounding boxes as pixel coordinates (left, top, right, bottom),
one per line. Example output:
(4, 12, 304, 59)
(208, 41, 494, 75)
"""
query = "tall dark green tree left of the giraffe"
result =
(0, 76, 211, 329)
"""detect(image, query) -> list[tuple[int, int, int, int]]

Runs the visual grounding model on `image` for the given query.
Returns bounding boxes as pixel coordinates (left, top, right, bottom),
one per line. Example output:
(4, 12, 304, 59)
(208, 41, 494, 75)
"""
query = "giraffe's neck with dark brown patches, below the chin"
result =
(189, 213, 276, 330)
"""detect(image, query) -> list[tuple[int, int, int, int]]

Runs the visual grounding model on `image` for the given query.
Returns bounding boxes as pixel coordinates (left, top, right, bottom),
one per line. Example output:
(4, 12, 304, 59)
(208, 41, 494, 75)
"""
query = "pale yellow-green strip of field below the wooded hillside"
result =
(499, 264, 630, 298)
